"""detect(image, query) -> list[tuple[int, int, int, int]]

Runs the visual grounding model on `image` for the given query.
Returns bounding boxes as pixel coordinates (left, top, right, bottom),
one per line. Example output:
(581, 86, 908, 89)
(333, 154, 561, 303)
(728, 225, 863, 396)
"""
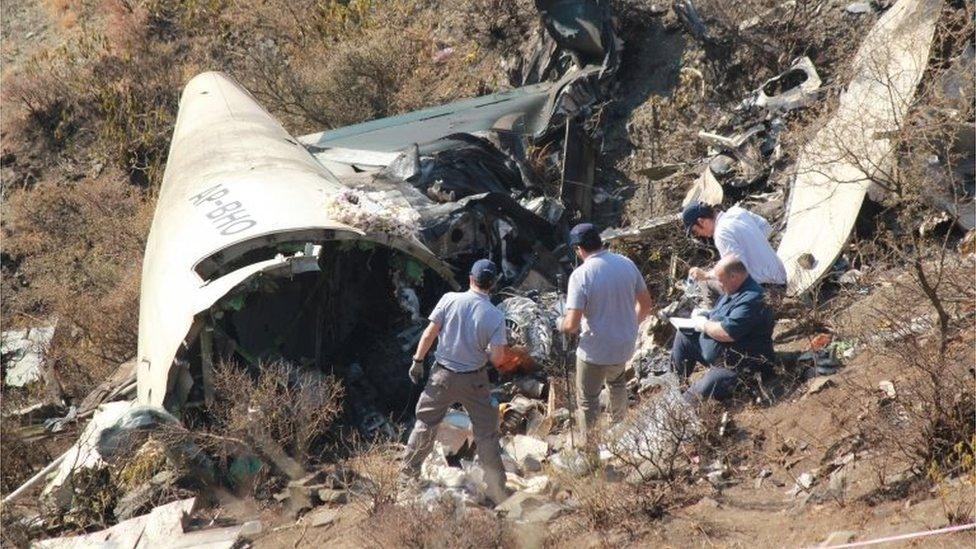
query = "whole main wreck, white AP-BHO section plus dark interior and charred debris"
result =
(137, 1, 621, 431)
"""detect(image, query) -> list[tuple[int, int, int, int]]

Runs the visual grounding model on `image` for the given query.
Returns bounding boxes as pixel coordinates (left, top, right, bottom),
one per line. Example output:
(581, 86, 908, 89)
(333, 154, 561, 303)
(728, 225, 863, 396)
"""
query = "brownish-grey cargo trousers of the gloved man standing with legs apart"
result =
(403, 364, 505, 503)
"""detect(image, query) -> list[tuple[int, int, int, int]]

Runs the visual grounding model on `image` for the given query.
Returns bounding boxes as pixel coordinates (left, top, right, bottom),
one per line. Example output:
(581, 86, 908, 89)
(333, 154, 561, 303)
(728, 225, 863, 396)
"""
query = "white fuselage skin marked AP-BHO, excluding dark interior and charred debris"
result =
(138, 73, 452, 412)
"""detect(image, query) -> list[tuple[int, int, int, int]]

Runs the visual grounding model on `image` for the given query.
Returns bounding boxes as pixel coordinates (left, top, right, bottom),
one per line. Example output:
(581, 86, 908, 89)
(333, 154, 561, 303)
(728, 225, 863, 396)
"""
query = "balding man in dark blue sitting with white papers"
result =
(671, 255, 775, 403)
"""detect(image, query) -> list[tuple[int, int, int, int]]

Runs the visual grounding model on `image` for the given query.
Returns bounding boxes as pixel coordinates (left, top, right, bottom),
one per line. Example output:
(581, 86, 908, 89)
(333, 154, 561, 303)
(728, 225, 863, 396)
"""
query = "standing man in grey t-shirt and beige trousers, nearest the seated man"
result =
(560, 223, 651, 432)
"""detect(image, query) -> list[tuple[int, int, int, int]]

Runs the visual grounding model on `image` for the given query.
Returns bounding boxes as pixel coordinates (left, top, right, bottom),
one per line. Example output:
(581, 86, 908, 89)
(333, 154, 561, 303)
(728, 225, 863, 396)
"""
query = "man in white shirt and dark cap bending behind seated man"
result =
(681, 201, 786, 287)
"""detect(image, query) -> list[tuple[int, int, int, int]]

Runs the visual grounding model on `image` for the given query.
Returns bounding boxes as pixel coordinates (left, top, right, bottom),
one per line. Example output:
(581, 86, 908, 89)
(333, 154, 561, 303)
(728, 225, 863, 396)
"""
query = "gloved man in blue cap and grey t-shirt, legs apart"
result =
(402, 259, 508, 504)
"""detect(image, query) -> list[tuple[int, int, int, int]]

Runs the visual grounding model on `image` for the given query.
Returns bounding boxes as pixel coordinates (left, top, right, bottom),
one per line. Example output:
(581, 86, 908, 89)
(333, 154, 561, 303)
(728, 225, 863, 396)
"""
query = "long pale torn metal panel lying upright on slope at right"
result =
(777, 0, 943, 295)
